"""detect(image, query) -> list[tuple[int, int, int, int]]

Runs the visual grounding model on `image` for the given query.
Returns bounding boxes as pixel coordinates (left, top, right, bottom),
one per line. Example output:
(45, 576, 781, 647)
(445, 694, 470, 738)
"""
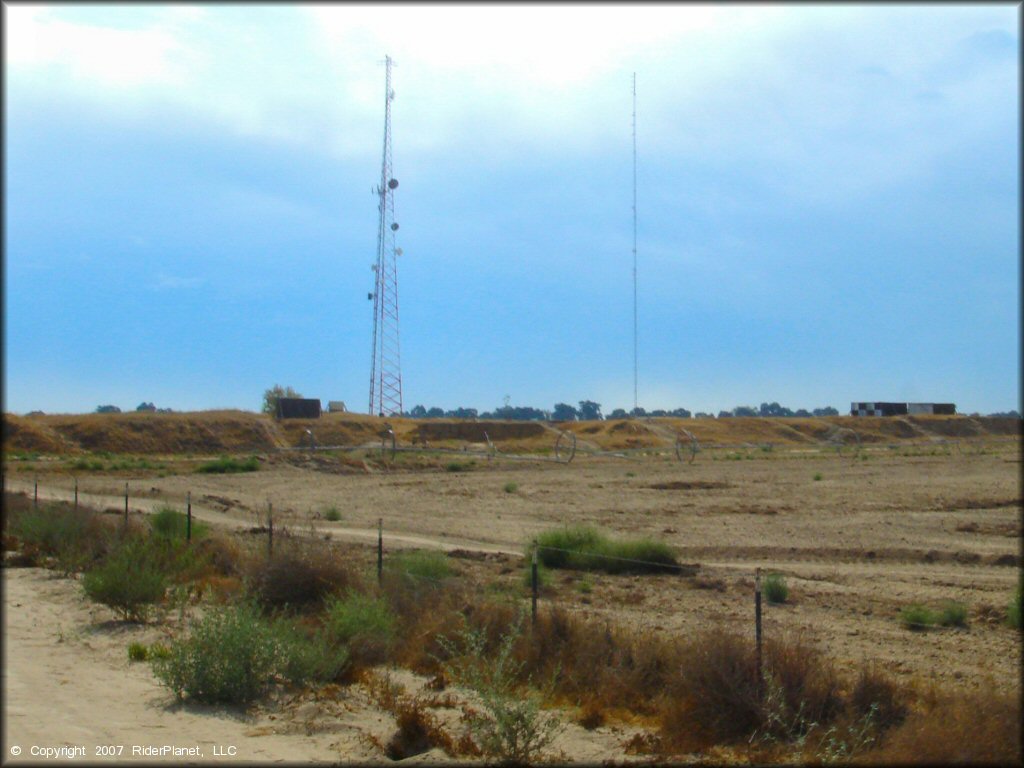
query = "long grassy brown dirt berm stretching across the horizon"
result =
(3, 411, 1021, 456)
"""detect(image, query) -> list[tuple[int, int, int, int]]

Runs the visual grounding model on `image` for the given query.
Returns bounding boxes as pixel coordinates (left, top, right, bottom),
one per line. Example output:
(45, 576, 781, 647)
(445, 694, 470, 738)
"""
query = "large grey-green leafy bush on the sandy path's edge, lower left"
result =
(153, 603, 286, 703)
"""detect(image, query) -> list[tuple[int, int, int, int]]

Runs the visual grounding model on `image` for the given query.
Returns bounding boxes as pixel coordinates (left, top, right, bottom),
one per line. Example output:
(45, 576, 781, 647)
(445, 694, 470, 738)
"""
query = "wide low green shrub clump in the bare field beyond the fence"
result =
(527, 525, 678, 573)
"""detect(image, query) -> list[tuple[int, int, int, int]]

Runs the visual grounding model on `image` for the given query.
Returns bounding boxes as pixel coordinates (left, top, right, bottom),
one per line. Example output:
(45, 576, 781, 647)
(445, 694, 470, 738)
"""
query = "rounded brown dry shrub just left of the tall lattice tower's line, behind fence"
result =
(246, 542, 358, 610)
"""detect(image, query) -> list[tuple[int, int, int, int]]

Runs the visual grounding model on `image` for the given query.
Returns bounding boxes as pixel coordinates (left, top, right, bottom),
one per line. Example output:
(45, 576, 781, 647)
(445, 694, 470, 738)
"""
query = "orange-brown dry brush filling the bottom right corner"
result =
(860, 691, 1022, 765)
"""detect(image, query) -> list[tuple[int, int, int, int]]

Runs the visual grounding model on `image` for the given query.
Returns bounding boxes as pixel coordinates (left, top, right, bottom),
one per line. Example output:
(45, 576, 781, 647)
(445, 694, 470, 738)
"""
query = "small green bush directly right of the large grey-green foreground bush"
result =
(324, 592, 398, 666)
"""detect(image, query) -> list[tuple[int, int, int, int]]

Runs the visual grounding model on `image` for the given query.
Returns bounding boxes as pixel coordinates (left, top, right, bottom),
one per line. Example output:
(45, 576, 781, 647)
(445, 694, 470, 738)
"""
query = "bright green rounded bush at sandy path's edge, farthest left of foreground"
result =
(82, 541, 168, 622)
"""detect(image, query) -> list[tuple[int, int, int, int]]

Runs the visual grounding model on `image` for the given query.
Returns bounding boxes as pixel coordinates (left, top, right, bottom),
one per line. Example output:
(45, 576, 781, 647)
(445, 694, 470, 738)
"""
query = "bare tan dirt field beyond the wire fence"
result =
(7, 438, 1021, 690)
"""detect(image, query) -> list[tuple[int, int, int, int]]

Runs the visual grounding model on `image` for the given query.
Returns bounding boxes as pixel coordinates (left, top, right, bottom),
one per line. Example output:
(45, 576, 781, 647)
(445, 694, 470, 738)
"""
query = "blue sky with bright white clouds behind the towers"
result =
(3, 3, 1022, 414)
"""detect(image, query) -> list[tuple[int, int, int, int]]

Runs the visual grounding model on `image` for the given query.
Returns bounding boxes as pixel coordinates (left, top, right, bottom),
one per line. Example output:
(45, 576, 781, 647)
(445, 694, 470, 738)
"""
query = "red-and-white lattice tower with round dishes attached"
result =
(370, 56, 401, 416)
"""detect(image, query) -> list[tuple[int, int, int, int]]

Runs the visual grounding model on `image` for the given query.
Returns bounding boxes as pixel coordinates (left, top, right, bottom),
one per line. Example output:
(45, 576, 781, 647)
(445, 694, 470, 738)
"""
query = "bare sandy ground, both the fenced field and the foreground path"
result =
(4, 445, 1022, 762)
